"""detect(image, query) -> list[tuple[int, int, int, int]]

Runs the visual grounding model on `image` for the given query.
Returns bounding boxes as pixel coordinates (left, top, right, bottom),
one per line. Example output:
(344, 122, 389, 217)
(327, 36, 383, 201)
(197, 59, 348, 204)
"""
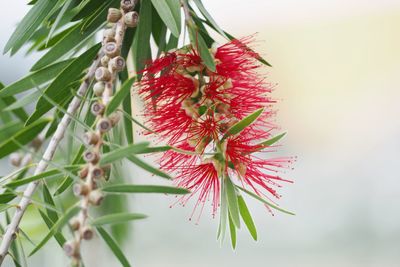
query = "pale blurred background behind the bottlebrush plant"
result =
(0, 0, 400, 267)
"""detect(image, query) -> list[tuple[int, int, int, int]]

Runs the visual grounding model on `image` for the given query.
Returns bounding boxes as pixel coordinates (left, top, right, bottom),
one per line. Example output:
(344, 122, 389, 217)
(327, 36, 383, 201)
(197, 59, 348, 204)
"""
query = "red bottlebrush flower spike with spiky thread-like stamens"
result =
(139, 37, 293, 237)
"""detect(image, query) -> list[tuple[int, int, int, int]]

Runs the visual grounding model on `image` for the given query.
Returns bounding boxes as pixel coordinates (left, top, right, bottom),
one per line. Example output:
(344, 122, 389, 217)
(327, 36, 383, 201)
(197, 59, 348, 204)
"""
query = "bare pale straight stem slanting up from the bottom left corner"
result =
(0, 52, 102, 266)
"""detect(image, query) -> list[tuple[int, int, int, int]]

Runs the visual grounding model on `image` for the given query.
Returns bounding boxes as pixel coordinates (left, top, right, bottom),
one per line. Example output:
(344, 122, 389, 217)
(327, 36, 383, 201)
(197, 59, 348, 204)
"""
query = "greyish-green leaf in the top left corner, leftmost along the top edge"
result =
(3, 0, 57, 54)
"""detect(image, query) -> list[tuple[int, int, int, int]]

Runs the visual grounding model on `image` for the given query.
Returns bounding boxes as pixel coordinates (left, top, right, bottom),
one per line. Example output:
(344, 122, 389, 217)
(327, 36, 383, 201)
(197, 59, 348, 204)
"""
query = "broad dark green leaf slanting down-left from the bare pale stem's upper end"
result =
(26, 44, 101, 125)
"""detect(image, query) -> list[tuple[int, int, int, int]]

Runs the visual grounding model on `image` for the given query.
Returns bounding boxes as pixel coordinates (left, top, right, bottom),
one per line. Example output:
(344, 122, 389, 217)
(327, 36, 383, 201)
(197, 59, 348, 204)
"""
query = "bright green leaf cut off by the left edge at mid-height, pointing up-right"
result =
(0, 119, 50, 159)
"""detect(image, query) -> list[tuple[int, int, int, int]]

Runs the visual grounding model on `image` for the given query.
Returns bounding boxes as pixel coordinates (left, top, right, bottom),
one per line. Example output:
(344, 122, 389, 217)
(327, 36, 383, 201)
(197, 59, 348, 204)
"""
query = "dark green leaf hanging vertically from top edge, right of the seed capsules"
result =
(133, 1, 152, 77)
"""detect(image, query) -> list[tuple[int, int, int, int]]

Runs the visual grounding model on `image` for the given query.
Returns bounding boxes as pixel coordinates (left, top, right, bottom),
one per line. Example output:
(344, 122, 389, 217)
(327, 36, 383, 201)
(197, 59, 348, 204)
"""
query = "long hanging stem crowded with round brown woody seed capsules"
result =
(64, 0, 138, 266)
